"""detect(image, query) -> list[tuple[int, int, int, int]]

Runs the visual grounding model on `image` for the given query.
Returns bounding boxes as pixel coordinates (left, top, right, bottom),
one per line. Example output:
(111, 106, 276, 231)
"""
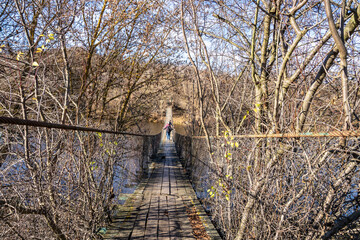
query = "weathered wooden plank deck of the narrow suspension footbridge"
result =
(104, 141, 221, 240)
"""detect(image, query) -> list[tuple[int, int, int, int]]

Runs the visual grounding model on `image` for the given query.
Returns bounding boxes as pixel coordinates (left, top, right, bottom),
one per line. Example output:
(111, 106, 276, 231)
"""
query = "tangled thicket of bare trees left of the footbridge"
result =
(0, 0, 176, 239)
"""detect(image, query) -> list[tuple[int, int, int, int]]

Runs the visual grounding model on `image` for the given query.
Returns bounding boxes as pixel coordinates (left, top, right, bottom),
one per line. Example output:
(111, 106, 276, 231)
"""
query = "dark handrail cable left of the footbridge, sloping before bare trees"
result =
(0, 117, 154, 137)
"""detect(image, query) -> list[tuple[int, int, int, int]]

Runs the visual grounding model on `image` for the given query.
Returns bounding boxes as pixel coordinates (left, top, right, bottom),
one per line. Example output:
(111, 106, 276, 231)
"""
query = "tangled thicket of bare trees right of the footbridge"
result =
(182, 0, 360, 239)
